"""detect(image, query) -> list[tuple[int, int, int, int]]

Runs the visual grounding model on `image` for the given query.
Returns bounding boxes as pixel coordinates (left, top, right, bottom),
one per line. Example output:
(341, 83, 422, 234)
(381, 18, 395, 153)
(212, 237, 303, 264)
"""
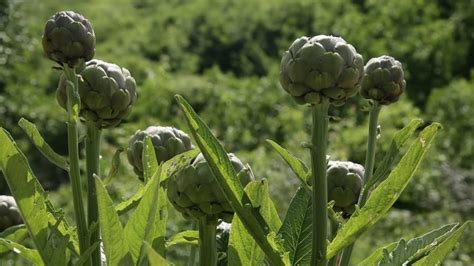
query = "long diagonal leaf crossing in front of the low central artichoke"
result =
(176, 95, 285, 265)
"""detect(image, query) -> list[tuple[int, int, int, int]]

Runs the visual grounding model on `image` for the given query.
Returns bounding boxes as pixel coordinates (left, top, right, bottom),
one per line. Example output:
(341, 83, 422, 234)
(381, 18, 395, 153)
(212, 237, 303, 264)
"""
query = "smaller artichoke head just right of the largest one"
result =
(360, 55, 406, 105)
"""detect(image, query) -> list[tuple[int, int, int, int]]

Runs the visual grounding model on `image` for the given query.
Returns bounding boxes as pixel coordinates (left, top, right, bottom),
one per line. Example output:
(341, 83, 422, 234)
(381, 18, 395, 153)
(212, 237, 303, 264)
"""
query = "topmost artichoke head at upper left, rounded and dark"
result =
(42, 11, 95, 67)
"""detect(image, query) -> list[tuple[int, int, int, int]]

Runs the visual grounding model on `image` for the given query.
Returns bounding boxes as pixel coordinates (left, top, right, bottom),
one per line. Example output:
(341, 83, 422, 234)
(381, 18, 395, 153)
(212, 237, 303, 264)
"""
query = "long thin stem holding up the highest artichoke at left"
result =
(64, 65, 89, 254)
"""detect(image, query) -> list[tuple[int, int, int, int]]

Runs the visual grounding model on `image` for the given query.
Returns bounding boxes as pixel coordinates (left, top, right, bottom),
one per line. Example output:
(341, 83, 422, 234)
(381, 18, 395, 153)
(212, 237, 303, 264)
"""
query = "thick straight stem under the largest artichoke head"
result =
(311, 98, 329, 266)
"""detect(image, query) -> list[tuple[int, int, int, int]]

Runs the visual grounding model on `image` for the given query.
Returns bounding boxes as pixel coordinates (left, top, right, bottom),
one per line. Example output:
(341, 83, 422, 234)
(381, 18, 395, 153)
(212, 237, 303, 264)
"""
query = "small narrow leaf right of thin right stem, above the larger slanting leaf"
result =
(366, 119, 423, 188)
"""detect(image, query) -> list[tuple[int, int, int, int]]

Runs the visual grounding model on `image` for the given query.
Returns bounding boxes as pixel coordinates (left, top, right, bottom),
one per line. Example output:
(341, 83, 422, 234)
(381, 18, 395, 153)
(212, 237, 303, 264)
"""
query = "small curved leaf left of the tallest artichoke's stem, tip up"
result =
(18, 118, 69, 171)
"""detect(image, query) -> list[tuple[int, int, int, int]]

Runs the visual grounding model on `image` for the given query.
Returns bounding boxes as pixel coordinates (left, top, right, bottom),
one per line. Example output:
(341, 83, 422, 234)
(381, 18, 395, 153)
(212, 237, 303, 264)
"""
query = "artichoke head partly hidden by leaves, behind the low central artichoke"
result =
(127, 126, 193, 180)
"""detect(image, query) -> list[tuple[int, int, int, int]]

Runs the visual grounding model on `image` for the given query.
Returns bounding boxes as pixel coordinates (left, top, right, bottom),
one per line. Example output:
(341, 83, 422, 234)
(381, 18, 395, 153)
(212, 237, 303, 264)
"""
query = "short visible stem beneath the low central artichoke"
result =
(199, 217, 217, 266)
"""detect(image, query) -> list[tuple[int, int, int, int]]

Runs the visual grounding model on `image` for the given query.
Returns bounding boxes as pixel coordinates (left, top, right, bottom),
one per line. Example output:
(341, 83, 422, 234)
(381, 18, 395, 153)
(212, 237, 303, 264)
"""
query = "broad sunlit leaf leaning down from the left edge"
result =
(0, 128, 78, 265)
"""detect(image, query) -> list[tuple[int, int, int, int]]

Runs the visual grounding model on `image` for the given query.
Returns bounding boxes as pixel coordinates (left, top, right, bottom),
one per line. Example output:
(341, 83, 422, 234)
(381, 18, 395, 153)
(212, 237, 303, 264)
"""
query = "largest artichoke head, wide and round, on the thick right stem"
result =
(280, 35, 364, 106)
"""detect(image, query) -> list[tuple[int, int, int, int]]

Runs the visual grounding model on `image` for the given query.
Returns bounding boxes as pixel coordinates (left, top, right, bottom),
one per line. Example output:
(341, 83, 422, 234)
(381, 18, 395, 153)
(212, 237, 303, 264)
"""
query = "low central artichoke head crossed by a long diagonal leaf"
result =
(167, 153, 253, 223)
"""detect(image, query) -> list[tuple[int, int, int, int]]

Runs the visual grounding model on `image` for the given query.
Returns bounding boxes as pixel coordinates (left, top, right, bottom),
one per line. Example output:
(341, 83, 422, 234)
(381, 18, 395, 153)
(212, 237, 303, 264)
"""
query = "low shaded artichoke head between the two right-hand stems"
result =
(327, 161, 364, 217)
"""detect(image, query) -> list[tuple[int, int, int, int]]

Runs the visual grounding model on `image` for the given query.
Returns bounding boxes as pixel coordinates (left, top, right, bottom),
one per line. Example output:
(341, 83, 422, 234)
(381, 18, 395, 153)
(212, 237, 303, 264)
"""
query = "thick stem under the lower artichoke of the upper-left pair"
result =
(86, 121, 101, 266)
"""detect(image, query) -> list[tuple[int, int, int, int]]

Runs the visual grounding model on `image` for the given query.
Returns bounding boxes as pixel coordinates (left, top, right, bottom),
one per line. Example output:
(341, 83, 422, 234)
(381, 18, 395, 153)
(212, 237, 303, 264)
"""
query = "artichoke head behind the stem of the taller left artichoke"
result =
(56, 59, 137, 128)
